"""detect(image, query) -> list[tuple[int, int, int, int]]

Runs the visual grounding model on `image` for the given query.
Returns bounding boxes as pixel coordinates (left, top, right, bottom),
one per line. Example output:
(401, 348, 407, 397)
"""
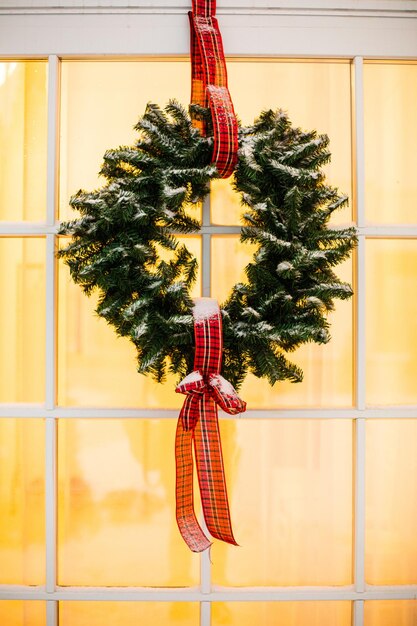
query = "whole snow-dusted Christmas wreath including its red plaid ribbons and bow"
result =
(56, 0, 356, 552)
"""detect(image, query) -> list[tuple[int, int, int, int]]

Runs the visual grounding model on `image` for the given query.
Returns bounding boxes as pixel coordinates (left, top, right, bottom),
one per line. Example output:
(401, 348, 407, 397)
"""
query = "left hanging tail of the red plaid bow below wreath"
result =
(175, 417, 211, 552)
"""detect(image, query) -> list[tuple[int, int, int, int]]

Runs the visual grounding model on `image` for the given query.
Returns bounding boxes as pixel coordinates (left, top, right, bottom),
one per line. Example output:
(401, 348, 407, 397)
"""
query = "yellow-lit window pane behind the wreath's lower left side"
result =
(58, 237, 201, 409)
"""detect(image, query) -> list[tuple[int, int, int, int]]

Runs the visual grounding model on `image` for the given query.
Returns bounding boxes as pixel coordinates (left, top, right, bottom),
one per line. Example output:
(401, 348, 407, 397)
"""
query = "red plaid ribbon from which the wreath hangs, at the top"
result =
(188, 0, 238, 178)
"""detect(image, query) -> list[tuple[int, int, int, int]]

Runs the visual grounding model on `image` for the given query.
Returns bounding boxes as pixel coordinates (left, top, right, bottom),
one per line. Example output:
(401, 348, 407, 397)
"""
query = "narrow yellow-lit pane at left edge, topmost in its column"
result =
(0, 61, 47, 222)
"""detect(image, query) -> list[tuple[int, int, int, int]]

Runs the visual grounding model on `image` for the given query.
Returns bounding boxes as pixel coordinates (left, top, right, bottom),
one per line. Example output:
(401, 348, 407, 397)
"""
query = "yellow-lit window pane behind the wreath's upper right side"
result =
(211, 59, 352, 224)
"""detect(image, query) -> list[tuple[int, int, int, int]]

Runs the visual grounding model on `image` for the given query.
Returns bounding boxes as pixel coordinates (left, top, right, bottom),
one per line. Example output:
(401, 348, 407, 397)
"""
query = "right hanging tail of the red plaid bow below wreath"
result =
(194, 396, 238, 546)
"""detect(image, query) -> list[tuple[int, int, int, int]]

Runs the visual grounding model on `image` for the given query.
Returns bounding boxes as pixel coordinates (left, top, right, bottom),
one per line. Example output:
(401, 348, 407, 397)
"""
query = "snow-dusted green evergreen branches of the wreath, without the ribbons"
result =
(58, 101, 356, 388)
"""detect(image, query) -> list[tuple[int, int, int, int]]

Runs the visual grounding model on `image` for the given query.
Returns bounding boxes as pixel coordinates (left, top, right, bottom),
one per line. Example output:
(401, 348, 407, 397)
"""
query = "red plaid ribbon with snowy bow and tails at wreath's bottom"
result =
(175, 299, 246, 552)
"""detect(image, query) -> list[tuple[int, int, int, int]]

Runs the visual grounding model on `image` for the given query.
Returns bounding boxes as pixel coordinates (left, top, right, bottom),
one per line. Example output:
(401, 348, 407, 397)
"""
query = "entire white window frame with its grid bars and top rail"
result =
(0, 0, 417, 626)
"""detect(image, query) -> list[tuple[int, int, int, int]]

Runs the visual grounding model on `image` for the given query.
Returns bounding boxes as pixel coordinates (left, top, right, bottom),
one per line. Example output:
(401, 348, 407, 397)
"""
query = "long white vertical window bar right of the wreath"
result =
(353, 57, 366, 604)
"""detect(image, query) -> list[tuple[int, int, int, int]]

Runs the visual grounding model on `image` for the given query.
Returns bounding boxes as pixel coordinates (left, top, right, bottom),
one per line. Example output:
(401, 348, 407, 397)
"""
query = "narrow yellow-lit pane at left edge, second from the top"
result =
(0, 238, 45, 402)
